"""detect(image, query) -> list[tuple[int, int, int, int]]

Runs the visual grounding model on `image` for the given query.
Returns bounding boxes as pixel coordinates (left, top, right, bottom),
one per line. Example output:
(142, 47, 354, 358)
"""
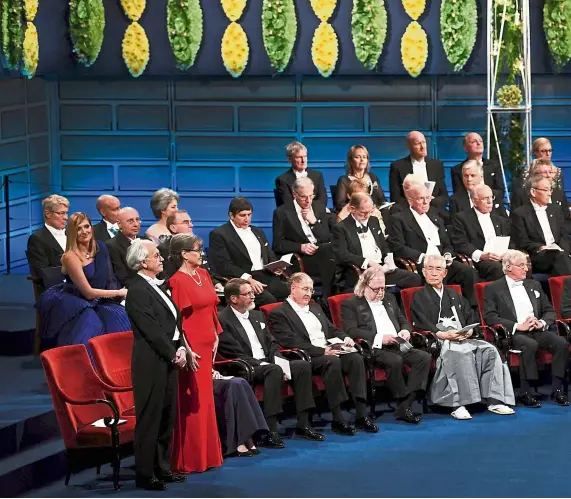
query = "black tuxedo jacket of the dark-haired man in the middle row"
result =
(208, 222, 276, 277)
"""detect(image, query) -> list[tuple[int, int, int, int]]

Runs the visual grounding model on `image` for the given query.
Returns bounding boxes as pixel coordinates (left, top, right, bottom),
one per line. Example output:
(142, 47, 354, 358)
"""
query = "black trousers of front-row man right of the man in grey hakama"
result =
(513, 331, 569, 381)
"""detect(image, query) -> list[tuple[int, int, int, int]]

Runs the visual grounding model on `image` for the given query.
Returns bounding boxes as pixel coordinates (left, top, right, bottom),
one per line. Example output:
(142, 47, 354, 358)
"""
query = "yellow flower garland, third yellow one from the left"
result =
(220, 0, 250, 78)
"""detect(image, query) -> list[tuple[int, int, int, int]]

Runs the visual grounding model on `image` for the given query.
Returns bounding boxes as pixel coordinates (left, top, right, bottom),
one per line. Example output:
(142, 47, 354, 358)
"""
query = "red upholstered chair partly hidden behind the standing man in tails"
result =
(89, 331, 135, 416)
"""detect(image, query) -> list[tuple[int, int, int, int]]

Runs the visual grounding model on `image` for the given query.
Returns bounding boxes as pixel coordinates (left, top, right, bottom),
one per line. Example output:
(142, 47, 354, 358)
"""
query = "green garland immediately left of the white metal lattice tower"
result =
(440, 0, 478, 71)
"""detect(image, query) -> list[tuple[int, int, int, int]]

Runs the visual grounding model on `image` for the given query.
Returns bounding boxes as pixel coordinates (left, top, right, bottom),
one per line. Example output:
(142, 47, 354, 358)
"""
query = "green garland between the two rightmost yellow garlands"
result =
(351, 0, 387, 70)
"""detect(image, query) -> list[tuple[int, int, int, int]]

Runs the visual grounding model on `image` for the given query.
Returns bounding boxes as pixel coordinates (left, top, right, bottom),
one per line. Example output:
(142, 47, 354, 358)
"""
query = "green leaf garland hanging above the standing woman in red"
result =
(167, 0, 203, 71)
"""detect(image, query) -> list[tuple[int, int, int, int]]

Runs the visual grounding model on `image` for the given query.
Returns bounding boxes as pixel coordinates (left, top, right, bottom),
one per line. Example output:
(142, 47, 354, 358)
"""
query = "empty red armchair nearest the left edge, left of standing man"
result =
(40, 345, 135, 490)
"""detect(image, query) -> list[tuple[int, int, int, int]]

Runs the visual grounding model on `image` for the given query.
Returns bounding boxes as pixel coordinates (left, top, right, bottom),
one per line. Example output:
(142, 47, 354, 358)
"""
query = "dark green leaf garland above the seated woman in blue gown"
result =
(69, 0, 105, 67)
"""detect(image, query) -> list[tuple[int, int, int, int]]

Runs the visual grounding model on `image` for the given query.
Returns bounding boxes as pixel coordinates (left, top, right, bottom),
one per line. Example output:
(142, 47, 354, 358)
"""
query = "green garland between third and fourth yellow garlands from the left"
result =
(262, 0, 297, 73)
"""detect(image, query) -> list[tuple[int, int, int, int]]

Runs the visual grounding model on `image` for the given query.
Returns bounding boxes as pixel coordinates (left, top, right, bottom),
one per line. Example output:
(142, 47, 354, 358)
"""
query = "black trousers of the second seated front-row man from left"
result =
(311, 353, 367, 408)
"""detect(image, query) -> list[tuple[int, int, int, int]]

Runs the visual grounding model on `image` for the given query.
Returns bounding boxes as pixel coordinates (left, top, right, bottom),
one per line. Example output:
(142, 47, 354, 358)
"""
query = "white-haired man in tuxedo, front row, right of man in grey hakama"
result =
(484, 250, 569, 407)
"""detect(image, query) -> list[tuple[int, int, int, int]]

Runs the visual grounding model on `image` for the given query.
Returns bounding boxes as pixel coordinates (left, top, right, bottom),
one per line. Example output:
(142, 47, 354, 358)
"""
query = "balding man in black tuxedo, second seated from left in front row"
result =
(269, 272, 379, 435)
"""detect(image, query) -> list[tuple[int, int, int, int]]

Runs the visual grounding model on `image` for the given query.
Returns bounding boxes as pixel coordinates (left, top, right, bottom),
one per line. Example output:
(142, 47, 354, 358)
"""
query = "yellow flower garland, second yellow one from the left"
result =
(121, 0, 151, 78)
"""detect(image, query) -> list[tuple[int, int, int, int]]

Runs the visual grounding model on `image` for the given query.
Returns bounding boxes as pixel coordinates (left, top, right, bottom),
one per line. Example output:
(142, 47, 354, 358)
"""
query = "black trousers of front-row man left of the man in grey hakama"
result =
(373, 345, 432, 399)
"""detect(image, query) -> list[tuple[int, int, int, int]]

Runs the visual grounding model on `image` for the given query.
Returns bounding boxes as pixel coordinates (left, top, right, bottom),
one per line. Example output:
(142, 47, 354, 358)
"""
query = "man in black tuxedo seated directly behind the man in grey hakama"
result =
(388, 184, 477, 307)
